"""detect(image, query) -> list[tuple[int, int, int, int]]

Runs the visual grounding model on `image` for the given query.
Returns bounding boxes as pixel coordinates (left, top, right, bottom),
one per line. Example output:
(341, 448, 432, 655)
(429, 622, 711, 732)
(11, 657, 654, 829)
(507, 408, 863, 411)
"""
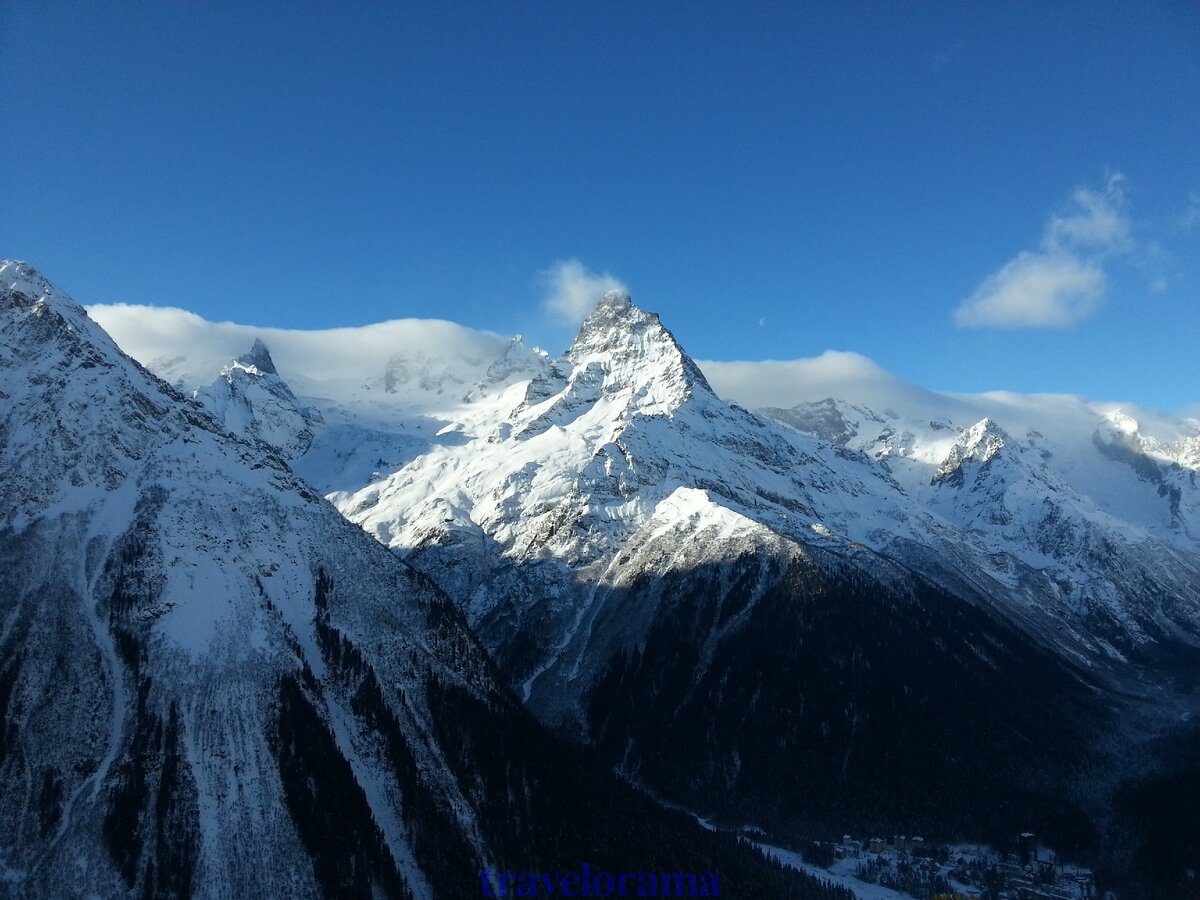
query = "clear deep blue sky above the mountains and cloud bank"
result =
(7, 0, 1200, 409)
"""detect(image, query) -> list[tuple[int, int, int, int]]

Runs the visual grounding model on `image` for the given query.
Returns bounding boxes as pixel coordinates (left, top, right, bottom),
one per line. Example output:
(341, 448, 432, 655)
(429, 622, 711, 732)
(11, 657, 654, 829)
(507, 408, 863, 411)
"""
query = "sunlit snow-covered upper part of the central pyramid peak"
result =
(334, 294, 911, 704)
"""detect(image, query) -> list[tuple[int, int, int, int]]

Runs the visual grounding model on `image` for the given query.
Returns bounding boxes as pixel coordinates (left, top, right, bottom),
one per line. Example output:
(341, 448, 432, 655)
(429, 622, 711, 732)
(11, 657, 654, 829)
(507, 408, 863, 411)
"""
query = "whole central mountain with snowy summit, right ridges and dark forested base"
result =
(87, 274, 1200, 883)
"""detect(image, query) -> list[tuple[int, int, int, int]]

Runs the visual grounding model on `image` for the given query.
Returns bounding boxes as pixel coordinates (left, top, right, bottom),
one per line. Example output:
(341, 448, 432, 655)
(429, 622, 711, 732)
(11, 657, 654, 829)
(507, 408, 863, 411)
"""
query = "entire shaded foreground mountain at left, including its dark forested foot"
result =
(0, 256, 846, 898)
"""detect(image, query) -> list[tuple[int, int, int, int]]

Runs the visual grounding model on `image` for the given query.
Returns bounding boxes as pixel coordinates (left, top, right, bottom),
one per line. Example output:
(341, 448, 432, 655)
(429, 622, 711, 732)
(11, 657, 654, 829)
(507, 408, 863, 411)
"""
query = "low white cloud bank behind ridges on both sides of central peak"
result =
(88, 294, 1200, 437)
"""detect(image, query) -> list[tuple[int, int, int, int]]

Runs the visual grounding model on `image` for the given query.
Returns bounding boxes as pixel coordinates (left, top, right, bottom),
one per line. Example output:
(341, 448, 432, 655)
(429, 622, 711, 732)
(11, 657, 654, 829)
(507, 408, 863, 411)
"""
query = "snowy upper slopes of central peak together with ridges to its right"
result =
(334, 294, 1200, 708)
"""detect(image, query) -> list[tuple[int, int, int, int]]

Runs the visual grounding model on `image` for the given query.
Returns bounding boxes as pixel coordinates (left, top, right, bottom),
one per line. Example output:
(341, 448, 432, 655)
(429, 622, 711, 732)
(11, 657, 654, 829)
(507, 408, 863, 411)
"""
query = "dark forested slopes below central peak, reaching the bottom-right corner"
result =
(582, 549, 1200, 900)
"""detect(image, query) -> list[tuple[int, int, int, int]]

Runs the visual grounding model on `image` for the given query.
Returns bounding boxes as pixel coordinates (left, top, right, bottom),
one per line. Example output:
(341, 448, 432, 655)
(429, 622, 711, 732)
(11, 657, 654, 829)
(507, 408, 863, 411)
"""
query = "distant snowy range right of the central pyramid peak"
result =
(763, 400, 1200, 652)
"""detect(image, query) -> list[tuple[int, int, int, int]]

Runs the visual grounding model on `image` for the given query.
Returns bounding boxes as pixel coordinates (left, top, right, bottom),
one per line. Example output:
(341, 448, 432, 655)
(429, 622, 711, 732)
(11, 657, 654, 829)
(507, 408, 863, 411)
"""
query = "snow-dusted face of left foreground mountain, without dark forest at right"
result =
(0, 263, 472, 896)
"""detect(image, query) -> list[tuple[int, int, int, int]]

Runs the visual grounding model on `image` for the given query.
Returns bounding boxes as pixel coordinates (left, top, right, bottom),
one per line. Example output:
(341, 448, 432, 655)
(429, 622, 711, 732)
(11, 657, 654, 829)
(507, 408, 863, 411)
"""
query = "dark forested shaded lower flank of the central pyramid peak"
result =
(587, 560, 1112, 850)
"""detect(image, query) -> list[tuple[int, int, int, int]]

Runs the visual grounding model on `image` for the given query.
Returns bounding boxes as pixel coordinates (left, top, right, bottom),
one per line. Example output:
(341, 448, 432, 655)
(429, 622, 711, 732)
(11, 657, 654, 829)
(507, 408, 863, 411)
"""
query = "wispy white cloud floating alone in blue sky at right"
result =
(954, 174, 1132, 329)
